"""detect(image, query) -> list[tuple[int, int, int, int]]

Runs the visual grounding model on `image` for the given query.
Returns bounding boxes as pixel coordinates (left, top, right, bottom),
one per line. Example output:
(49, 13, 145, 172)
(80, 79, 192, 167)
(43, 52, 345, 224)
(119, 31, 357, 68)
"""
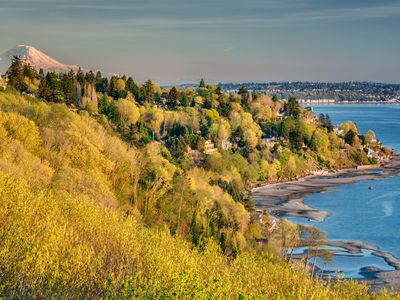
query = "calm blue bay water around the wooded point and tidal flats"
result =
(289, 105, 400, 277)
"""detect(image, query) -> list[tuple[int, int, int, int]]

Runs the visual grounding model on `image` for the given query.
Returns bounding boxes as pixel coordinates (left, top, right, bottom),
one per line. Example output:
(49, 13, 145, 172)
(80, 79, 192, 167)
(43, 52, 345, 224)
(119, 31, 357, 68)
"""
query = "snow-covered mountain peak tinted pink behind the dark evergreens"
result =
(0, 45, 79, 74)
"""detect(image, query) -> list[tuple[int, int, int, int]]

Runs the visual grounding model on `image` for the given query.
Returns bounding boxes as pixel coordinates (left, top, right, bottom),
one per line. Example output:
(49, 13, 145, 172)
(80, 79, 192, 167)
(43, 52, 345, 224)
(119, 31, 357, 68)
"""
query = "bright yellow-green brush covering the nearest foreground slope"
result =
(0, 173, 396, 299)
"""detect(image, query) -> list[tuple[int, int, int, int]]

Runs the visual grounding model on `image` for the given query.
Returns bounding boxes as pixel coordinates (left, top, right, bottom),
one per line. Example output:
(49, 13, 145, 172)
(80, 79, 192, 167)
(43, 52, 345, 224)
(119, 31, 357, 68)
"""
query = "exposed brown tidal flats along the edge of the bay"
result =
(253, 153, 400, 290)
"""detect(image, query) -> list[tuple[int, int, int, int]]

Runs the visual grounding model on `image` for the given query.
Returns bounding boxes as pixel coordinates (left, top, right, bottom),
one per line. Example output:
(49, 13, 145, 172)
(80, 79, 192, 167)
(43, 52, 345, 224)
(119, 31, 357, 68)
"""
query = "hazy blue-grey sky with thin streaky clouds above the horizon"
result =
(0, 0, 400, 83)
